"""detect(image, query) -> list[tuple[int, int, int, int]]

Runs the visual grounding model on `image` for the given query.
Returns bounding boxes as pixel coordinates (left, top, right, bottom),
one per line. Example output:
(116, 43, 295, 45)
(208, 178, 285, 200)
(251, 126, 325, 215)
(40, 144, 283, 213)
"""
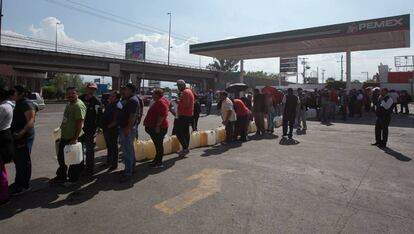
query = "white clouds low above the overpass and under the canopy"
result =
(3, 17, 414, 81)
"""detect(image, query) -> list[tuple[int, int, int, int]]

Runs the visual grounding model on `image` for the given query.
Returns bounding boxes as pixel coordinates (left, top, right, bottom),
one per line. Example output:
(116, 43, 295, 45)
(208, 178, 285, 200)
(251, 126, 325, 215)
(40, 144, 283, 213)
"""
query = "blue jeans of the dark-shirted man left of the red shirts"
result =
(119, 127, 138, 176)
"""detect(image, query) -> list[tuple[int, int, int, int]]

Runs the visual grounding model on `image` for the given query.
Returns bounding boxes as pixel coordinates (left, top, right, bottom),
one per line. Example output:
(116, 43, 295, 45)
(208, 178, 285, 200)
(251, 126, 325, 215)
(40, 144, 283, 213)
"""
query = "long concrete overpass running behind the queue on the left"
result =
(0, 46, 220, 89)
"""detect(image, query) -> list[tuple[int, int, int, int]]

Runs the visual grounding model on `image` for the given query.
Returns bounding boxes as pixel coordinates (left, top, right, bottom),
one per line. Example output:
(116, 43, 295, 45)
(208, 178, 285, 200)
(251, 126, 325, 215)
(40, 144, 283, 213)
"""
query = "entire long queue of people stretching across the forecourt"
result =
(0, 80, 410, 204)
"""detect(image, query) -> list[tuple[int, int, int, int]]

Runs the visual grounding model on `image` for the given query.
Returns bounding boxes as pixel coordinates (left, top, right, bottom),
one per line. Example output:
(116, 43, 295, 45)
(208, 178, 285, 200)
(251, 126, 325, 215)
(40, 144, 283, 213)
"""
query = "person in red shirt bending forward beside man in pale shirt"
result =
(233, 99, 251, 141)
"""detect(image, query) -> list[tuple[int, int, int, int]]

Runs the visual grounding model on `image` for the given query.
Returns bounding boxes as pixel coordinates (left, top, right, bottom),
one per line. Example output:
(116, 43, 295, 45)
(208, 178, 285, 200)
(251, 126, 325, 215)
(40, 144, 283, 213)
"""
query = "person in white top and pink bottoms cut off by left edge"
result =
(0, 88, 14, 207)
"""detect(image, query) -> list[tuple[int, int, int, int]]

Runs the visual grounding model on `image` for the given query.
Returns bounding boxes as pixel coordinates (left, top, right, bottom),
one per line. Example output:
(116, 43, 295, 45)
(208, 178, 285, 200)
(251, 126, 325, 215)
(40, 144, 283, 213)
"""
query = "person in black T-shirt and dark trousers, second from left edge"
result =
(9, 85, 35, 195)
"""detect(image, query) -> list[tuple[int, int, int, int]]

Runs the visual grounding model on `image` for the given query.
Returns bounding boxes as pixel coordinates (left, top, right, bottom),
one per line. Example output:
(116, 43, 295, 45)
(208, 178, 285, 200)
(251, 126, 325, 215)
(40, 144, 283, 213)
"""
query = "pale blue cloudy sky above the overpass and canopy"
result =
(2, 0, 414, 83)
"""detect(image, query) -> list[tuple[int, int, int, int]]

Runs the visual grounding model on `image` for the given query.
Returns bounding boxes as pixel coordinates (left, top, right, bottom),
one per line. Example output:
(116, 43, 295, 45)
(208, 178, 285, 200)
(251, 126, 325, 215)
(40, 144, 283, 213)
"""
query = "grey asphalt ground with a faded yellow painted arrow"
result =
(0, 105, 414, 233)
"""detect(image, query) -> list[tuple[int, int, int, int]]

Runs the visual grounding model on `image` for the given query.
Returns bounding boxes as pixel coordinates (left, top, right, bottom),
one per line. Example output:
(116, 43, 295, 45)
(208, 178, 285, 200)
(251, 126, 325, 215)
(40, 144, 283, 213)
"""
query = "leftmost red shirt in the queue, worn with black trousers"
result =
(144, 98, 169, 128)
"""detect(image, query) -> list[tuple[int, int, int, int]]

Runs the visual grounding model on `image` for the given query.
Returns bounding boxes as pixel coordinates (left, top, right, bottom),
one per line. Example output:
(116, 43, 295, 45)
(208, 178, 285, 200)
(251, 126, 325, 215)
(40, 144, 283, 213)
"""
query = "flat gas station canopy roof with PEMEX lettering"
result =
(190, 14, 410, 59)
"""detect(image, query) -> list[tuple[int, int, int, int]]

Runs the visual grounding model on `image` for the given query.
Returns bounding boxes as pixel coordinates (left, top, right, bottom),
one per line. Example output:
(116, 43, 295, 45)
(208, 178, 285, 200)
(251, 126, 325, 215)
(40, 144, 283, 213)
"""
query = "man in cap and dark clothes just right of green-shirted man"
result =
(79, 83, 102, 176)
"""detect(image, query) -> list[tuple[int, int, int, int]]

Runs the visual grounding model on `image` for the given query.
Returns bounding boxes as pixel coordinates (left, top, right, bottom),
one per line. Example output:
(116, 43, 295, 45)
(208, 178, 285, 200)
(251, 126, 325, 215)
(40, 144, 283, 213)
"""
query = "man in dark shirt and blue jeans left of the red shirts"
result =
(118, 83, 141, 183)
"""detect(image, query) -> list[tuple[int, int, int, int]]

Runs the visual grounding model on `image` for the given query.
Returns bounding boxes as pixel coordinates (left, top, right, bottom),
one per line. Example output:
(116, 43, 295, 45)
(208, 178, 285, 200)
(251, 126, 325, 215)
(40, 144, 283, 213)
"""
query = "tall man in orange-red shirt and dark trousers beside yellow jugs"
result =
(176, 80, 194, 156)
